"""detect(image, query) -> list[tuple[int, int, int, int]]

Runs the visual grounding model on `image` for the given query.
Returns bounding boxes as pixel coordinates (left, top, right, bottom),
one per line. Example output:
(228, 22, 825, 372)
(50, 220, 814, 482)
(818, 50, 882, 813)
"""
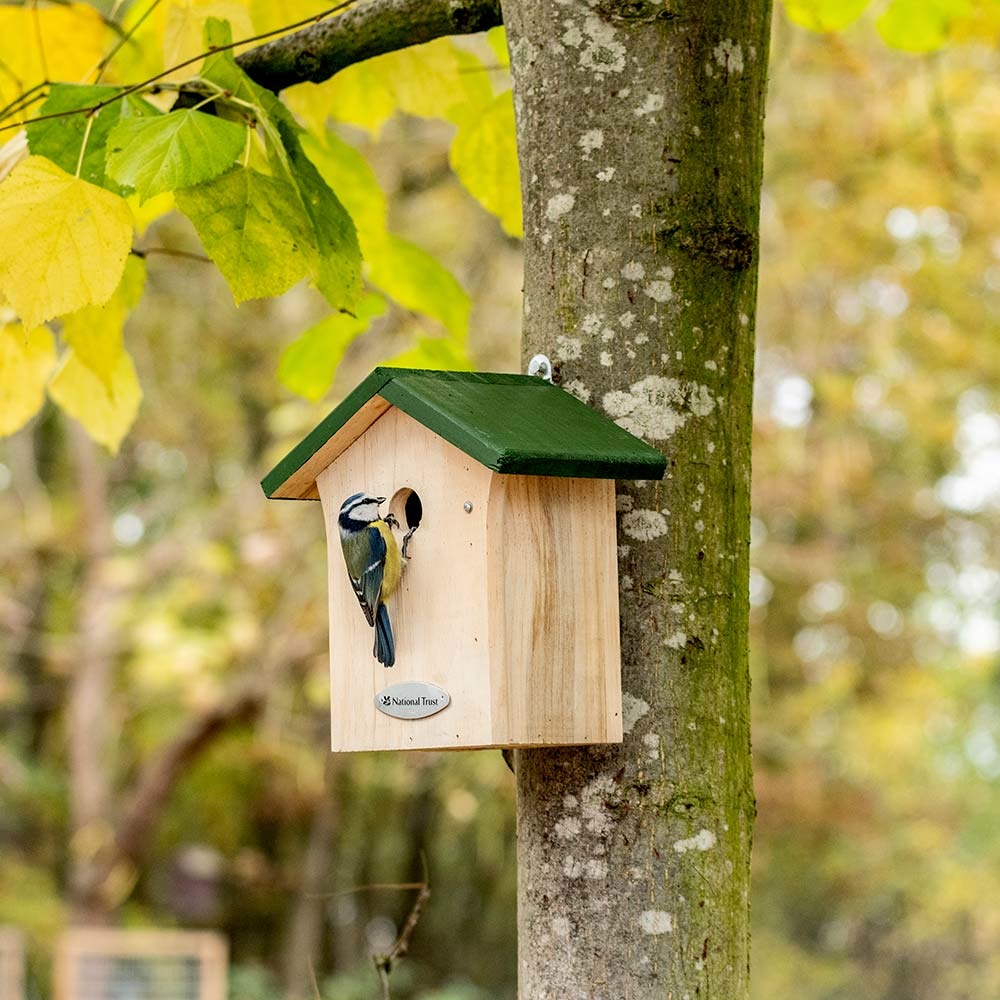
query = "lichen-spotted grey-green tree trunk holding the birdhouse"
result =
(503, 0, 770, 1000)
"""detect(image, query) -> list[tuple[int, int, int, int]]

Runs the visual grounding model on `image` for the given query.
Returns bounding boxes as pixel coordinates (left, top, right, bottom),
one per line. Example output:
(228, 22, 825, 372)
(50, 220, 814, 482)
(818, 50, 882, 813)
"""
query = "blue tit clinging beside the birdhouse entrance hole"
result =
(337, 493, 403, 667)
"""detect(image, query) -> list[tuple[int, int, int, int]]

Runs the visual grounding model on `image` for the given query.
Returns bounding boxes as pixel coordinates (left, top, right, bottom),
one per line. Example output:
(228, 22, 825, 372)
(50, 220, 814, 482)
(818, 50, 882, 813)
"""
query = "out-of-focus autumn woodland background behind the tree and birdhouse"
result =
(0, 0, 1000, 1000)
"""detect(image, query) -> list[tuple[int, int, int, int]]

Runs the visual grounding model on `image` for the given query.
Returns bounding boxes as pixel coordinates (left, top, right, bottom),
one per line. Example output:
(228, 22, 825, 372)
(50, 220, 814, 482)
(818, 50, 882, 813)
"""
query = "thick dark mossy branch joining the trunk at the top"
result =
(236, 0, 503, 93)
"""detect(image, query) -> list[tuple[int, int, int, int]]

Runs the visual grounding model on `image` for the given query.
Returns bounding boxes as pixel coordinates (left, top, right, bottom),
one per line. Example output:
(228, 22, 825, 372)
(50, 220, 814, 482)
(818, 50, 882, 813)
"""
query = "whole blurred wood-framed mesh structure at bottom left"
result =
(53, 927, 228, 1000)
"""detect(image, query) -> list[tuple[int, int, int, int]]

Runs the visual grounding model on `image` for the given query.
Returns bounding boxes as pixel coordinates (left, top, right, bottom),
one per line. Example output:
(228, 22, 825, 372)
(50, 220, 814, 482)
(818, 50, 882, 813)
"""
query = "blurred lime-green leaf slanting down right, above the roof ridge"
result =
(369, 235, 470, 343)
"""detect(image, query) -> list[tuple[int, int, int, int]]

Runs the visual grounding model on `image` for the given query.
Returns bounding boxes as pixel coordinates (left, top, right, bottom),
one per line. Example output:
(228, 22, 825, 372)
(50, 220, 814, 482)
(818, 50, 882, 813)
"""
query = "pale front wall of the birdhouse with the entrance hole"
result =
(317, 408, 495, 751)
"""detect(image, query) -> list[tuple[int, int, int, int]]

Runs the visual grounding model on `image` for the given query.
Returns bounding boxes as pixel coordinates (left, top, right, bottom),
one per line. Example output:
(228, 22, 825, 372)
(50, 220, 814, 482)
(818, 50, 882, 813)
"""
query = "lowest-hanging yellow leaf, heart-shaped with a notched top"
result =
(49, 348, 142, 454)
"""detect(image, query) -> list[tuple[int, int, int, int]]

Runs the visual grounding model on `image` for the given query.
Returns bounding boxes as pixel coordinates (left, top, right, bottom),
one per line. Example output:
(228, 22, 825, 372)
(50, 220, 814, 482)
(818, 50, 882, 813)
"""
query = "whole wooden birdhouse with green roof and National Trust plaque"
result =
(262, 368, 666, 751)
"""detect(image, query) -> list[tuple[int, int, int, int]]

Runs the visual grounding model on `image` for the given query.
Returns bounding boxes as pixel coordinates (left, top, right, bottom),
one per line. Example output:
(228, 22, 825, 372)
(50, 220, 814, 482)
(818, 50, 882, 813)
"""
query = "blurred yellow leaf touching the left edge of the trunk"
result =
(449, 90, 524, 237)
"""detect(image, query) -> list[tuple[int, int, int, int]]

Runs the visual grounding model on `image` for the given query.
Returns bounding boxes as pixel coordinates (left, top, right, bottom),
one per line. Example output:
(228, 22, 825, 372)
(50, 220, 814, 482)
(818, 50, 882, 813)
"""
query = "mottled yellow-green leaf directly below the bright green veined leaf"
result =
(176, 167, 315, 303)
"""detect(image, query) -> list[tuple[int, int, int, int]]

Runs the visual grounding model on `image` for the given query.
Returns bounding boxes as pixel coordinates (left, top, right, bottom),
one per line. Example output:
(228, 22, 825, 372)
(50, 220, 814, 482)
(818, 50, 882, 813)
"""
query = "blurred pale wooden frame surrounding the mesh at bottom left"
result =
(53, 927, 229, 1000)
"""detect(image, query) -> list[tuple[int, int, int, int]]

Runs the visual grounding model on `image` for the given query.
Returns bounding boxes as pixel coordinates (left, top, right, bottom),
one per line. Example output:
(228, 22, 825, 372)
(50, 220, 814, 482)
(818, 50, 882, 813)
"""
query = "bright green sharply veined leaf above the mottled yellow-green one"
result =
(107, 109, 247, 201)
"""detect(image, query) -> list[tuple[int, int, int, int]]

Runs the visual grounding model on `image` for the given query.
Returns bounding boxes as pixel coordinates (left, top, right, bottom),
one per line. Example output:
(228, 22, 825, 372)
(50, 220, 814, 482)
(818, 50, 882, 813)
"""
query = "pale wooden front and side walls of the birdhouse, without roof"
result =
(318, 408, 621, 751)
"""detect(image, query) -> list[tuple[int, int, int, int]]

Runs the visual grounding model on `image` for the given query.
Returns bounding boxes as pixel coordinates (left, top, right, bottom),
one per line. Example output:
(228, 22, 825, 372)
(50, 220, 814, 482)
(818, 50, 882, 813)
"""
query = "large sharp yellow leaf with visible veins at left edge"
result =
(0, 156, 132, 328)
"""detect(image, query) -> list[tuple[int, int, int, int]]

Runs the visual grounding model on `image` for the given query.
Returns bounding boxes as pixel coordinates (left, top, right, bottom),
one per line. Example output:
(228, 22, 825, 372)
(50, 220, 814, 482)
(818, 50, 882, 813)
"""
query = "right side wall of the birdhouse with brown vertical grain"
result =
(488, 476, 622, 746)
